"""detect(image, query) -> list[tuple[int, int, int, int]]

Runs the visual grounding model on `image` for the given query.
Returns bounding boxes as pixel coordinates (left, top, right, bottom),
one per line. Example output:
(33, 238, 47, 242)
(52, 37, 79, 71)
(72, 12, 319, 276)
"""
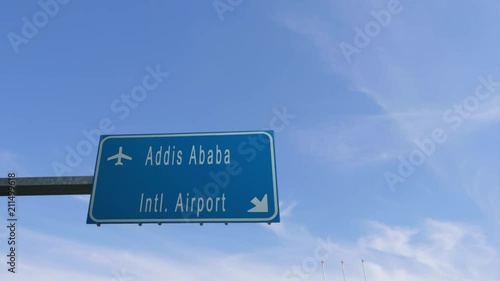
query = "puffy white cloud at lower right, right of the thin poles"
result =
(360, 220, 498, 280)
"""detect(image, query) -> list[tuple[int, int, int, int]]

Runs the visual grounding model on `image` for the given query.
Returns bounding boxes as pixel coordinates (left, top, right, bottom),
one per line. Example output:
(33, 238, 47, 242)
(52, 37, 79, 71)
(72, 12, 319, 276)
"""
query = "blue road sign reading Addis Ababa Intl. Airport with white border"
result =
(87, 131, 280, 224)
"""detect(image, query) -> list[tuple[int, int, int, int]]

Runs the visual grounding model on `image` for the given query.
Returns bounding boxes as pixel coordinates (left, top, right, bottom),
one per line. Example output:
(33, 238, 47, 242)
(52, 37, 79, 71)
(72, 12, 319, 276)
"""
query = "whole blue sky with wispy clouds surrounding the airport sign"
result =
(0, 0, 500, 281)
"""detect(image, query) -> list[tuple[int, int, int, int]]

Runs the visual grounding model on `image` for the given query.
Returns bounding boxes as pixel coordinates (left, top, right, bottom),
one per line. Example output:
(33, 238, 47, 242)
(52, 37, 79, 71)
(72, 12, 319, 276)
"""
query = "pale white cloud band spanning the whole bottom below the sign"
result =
(0, 220, 499, 281)
